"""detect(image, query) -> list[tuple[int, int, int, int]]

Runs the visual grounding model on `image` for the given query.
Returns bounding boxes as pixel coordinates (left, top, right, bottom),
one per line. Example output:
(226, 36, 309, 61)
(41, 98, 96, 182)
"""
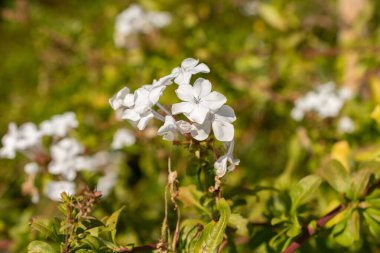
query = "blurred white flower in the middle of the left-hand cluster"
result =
(48, 138, 87, 180)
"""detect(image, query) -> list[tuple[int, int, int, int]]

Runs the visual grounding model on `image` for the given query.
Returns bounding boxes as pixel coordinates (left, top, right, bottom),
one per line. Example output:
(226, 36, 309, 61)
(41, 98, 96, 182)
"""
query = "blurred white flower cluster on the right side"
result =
(291, 82, 352, 121)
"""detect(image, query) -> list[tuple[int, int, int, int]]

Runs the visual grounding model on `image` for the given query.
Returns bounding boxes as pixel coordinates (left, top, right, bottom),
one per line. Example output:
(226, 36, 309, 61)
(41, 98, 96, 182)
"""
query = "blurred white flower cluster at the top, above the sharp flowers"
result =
(114, 4, 171, 48)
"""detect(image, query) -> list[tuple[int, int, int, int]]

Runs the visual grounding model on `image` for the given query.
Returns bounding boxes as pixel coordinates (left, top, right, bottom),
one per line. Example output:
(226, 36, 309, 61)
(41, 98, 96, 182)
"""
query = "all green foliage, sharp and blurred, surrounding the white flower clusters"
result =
(0, 0, 380, 253)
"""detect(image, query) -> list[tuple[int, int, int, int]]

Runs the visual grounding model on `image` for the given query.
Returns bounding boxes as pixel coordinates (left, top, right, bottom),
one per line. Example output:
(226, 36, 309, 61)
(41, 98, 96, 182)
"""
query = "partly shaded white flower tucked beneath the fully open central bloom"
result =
(191, 105, 236, 142)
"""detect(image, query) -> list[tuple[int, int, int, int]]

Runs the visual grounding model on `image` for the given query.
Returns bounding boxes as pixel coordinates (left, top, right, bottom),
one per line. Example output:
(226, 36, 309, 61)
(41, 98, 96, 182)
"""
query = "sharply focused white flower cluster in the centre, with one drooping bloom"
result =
(110, 58, 239, 177)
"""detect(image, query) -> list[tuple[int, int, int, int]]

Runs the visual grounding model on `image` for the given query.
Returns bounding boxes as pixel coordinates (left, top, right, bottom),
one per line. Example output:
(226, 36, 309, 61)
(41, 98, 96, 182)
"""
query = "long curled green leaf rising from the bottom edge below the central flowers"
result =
(191, 198, 231, 253)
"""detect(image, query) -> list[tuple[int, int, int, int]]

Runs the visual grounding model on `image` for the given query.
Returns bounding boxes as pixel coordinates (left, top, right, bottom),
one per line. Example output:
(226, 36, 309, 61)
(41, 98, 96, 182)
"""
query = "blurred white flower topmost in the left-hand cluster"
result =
(40, 112, 78, 137)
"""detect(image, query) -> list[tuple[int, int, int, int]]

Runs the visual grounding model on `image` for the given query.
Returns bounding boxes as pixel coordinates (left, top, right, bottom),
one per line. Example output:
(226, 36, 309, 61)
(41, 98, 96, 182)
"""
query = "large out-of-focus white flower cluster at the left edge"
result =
(0, 112, 131, 203)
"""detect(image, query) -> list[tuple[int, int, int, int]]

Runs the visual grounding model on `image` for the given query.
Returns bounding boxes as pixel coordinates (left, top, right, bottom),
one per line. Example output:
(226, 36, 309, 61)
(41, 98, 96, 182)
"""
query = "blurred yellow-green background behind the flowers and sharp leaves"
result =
(0, 0, 380, 252)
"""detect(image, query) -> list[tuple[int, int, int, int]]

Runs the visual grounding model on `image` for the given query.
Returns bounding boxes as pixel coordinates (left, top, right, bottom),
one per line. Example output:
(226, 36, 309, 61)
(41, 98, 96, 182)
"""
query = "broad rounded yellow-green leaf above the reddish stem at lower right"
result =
(322, 160, 351, 193)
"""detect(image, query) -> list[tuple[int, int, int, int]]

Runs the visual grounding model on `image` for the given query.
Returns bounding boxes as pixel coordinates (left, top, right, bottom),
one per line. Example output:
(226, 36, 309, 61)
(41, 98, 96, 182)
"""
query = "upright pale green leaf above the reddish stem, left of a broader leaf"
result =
(290, 175, 322, 212)
